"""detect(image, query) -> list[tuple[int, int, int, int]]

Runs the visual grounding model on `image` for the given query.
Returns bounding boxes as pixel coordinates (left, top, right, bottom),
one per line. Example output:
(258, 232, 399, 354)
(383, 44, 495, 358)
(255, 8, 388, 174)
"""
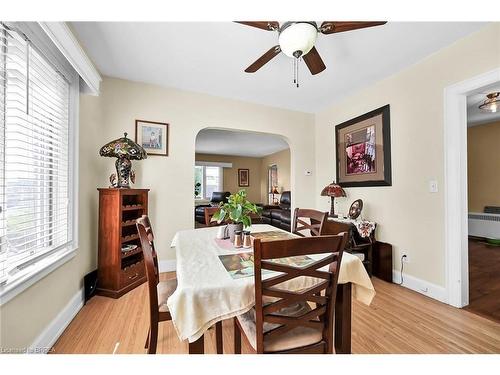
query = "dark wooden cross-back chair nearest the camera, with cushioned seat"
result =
(234, 233, 347, 354)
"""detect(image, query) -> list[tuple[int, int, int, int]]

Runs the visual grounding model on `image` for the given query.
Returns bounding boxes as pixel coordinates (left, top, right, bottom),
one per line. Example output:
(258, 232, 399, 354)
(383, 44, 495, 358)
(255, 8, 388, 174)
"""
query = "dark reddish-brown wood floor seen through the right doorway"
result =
(465, 240, 500, 323)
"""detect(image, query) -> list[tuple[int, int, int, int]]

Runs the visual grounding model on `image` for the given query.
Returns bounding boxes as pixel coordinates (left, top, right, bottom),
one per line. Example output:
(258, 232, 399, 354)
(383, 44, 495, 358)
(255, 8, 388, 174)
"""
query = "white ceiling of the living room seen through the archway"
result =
(195, 129, 289, 158)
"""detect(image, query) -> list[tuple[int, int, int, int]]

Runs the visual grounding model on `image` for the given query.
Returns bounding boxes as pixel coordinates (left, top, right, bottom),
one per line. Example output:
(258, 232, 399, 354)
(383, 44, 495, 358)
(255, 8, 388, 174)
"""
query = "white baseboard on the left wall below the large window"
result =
(28, 289, 84, 353)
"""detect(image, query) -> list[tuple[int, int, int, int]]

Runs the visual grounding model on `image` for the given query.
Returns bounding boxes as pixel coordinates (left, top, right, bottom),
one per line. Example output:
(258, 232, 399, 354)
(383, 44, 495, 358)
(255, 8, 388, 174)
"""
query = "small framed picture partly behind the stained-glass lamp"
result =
(135, 120, 168, 156)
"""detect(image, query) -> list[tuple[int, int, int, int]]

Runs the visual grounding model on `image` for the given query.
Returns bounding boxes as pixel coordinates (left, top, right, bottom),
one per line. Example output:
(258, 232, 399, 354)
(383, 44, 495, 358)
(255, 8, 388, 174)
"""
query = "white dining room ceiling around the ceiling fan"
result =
(71, 22, 485, 113)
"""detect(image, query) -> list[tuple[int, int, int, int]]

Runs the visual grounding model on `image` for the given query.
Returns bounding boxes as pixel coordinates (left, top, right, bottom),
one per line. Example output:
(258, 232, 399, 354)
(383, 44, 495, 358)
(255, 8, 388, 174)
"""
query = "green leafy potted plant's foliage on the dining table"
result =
(212, 189, 262, 228)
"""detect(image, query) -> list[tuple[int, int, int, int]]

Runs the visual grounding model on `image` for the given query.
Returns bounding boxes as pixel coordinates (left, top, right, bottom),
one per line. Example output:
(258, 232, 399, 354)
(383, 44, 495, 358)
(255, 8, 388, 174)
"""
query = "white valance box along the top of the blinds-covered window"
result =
(38, 22, 102, 95)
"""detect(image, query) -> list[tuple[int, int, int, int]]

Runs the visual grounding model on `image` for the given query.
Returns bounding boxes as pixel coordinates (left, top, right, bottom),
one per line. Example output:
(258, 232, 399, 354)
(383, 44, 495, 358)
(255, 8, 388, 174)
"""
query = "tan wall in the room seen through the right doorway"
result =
(467, 121, 500, 212)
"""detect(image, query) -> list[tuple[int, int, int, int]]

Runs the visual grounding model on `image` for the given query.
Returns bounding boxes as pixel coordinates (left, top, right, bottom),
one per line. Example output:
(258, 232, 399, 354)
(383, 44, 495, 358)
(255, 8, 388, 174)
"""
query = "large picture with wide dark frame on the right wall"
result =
(335, 104, 392, 187)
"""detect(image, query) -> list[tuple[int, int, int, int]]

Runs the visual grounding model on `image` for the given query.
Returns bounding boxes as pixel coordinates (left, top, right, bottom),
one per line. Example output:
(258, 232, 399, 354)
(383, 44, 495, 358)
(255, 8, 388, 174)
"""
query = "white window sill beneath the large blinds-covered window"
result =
(0, 245, 77, 306)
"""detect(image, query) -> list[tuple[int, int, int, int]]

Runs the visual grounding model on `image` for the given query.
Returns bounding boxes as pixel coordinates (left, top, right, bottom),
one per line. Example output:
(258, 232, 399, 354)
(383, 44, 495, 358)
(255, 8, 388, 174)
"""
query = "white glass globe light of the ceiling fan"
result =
(279, 22, 318, 58)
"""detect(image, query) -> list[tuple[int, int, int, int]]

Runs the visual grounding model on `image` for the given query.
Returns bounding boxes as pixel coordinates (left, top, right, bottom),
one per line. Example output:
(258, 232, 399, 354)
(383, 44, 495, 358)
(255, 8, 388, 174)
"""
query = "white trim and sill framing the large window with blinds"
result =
(0, 22, 80, 306)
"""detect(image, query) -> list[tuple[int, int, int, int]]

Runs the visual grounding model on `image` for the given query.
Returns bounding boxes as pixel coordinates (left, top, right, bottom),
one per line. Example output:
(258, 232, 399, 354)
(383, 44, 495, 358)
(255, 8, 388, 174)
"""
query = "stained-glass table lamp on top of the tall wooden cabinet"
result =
(99, 133, 148, 188)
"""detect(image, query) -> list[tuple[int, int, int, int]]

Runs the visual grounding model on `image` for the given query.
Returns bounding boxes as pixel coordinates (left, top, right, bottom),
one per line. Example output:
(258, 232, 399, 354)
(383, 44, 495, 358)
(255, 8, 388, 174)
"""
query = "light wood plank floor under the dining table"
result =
(50, 273, 500, 354)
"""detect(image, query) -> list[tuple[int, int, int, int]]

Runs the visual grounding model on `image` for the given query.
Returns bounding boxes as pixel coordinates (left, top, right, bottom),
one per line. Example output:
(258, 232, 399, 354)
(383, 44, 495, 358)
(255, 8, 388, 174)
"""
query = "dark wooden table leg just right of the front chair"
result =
(335, 283, 352, 354)
